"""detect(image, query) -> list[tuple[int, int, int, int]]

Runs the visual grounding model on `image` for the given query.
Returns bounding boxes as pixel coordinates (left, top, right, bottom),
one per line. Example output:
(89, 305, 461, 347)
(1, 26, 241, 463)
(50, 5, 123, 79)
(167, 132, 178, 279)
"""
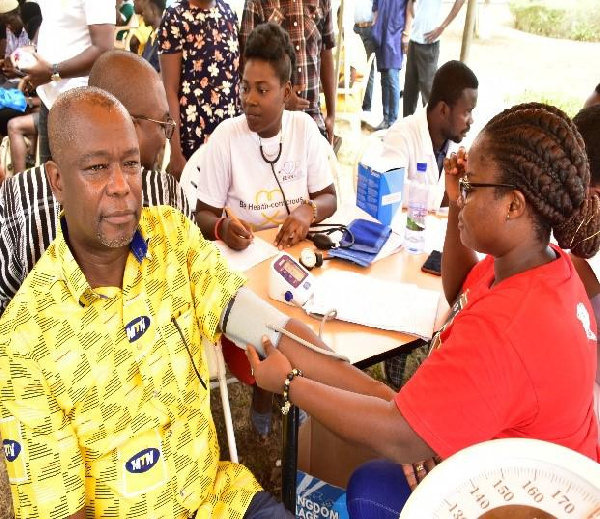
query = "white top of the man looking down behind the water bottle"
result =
(383, 106, 456, 211)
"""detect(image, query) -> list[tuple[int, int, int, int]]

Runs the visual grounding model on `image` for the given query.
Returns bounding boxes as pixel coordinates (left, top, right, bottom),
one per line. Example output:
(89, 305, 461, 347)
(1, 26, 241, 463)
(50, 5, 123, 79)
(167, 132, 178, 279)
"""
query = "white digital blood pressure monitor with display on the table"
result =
(269, 252, 315, 306)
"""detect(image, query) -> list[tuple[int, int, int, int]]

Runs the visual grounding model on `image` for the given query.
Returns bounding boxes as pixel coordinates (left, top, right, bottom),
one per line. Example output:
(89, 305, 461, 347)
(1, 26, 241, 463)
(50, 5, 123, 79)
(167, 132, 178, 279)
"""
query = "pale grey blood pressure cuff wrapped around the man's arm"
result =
(219, 287, 290, 358)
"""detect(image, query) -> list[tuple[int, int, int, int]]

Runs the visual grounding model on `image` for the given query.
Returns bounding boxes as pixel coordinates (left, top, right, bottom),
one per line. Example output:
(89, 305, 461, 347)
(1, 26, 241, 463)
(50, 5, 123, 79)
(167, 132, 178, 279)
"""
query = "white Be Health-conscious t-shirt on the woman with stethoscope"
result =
(198, 111, 333, 229)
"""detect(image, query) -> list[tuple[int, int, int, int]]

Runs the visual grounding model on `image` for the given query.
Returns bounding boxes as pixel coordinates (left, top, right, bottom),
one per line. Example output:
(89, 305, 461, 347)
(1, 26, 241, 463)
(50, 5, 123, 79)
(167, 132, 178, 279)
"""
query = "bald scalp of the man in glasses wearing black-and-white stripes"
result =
(88, 50, 164, 114)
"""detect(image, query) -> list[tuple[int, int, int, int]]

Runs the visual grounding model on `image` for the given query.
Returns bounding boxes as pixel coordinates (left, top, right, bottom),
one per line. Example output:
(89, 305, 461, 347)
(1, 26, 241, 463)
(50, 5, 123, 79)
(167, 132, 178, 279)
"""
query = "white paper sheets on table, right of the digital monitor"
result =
(307, 271, 440, 339)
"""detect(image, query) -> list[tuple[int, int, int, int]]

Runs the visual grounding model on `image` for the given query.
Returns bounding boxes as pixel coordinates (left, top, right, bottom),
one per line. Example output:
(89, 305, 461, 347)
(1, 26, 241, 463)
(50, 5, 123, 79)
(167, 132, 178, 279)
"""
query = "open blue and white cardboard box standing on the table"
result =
(356, 162, 405, 225)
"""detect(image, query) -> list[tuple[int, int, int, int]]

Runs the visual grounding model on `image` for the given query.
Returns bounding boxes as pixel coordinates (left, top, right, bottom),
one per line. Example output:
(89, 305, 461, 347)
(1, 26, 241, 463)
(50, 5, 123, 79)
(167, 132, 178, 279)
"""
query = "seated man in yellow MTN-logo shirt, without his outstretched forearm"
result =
(0, 88, 293, 519)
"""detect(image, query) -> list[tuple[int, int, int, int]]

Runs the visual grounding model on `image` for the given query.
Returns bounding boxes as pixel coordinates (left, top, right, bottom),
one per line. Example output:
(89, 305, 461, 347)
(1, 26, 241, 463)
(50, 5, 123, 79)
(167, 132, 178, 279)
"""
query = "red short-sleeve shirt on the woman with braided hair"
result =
(396, 248, 598, 461)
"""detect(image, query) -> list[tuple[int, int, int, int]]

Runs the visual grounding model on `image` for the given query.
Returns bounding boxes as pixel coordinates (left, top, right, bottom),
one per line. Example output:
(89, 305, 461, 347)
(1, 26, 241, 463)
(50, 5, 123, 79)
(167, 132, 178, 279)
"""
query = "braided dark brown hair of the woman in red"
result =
(483, 103, 600, 258)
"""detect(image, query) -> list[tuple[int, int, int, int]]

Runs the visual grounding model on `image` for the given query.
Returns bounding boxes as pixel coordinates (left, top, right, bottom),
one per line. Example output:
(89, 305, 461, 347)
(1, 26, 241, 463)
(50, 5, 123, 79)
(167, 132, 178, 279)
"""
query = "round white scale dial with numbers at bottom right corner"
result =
(400, 438, 600, 519)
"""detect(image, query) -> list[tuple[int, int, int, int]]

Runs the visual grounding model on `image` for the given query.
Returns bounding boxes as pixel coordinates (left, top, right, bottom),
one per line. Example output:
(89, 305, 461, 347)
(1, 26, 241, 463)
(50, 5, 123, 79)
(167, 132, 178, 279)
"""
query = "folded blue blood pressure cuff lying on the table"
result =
(329, 218, 392, 267)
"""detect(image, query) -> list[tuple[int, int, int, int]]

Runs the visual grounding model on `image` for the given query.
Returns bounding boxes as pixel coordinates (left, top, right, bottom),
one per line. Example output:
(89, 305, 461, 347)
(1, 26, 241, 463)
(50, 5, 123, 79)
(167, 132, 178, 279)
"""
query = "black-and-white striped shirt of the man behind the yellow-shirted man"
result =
(0, 166, 193, 314)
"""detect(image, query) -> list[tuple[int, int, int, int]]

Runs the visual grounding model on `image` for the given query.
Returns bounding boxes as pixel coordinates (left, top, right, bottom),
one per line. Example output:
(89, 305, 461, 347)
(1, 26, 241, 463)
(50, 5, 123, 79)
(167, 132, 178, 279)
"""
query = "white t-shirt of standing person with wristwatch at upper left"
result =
(37, 0, 116, 108)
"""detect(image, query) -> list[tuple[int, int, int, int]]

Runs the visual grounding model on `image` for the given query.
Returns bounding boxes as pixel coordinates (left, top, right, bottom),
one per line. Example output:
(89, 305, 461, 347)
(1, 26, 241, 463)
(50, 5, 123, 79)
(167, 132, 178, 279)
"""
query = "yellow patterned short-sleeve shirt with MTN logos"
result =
(0, 207, 260, 519)
